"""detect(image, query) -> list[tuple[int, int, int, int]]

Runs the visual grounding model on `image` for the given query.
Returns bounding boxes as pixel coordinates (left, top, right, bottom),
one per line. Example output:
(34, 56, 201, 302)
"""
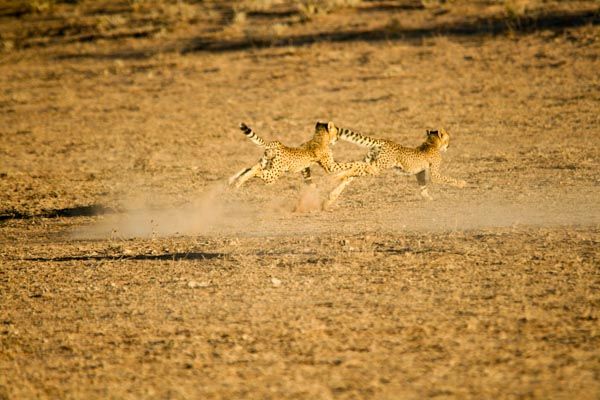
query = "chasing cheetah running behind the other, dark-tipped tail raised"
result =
(229, 122, 360, 188)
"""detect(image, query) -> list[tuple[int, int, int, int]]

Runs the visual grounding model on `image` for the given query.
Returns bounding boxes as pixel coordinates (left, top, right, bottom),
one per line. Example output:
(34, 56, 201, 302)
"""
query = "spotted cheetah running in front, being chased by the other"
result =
(323, 128, 466, 209)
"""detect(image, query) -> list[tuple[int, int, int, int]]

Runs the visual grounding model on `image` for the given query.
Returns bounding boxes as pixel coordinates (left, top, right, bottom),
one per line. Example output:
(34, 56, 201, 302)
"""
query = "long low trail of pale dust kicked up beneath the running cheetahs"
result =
(71, 185, 600, 239)
